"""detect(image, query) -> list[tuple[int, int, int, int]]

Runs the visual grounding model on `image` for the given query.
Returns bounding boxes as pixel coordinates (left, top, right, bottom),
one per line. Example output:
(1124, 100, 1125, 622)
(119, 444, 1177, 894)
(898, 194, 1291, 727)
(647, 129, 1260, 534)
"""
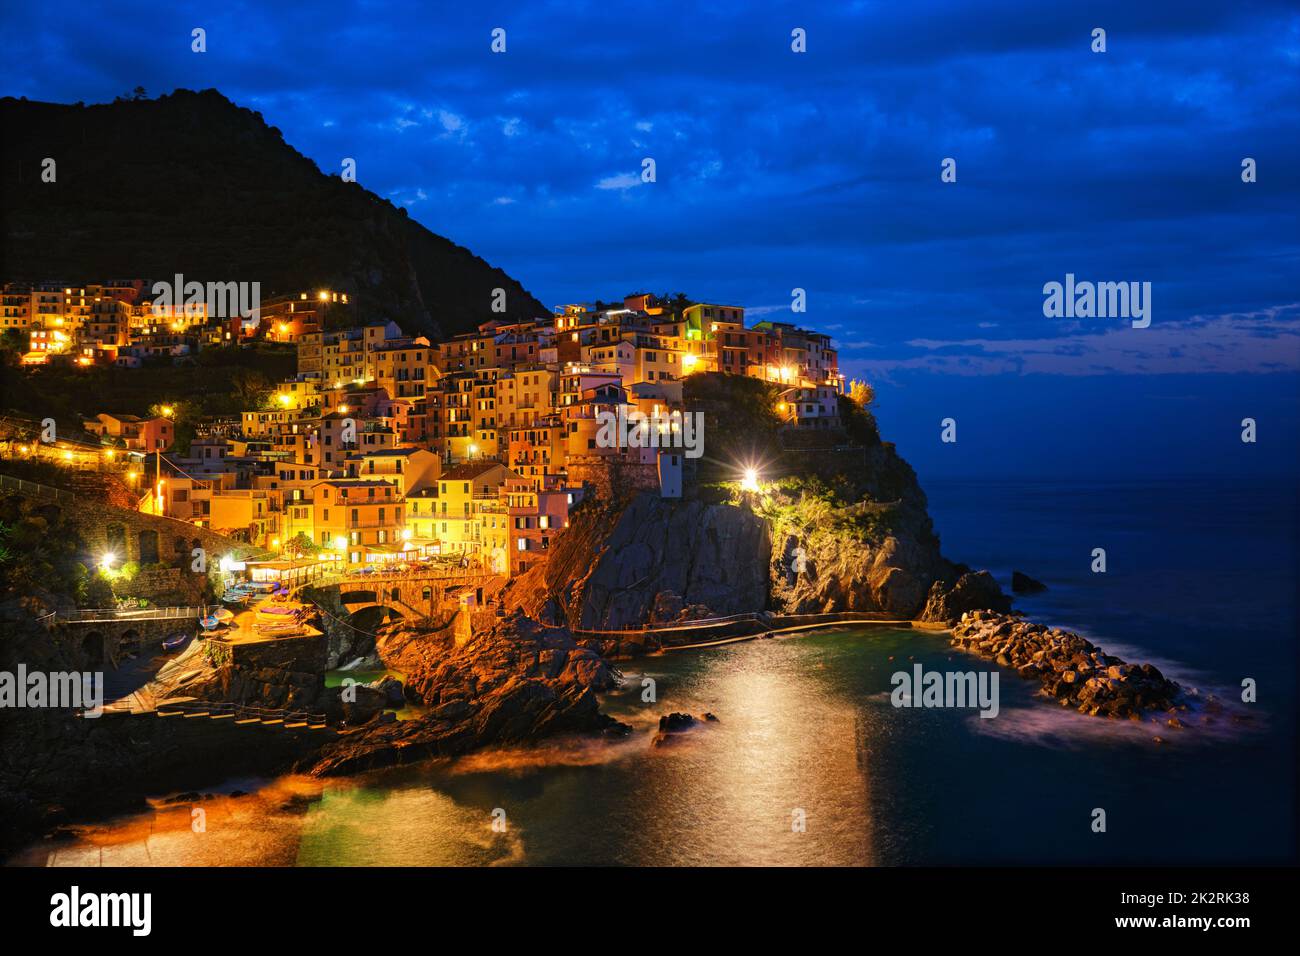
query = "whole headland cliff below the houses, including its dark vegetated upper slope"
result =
(506, 375, 987, 632)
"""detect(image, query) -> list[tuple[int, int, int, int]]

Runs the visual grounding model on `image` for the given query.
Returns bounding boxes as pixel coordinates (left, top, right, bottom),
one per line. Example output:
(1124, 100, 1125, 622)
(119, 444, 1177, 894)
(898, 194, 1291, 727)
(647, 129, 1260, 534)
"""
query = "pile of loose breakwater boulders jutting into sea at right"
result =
(952, 611, 1182, 727)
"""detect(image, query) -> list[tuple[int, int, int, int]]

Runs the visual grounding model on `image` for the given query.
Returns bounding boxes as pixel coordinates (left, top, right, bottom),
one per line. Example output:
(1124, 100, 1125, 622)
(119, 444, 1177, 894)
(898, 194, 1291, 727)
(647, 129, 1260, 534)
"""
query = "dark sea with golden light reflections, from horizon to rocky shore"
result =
(15, 481, 1297, 865)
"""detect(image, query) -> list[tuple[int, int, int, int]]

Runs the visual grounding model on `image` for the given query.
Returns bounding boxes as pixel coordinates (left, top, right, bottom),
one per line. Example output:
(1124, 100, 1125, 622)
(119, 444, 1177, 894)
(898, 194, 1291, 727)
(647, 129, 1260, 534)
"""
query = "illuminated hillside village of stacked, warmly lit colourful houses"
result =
(0, 280, 845, 583)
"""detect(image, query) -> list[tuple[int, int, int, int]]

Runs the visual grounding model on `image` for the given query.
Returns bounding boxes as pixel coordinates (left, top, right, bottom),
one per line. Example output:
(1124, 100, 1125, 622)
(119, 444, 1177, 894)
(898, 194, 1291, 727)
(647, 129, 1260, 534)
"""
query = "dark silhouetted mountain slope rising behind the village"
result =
(0, 90, 547, 334)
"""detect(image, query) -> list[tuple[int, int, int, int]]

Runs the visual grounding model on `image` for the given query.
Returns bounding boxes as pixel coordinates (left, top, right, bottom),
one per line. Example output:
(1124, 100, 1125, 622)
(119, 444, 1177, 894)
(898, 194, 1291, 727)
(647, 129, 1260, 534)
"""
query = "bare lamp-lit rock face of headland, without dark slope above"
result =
(507, 442, 987, 629)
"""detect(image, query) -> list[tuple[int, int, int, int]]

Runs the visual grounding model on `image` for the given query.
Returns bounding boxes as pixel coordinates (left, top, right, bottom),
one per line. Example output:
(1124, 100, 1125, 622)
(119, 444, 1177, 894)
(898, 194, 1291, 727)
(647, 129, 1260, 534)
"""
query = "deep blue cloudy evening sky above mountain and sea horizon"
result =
(0, 0, 1300, 480)
